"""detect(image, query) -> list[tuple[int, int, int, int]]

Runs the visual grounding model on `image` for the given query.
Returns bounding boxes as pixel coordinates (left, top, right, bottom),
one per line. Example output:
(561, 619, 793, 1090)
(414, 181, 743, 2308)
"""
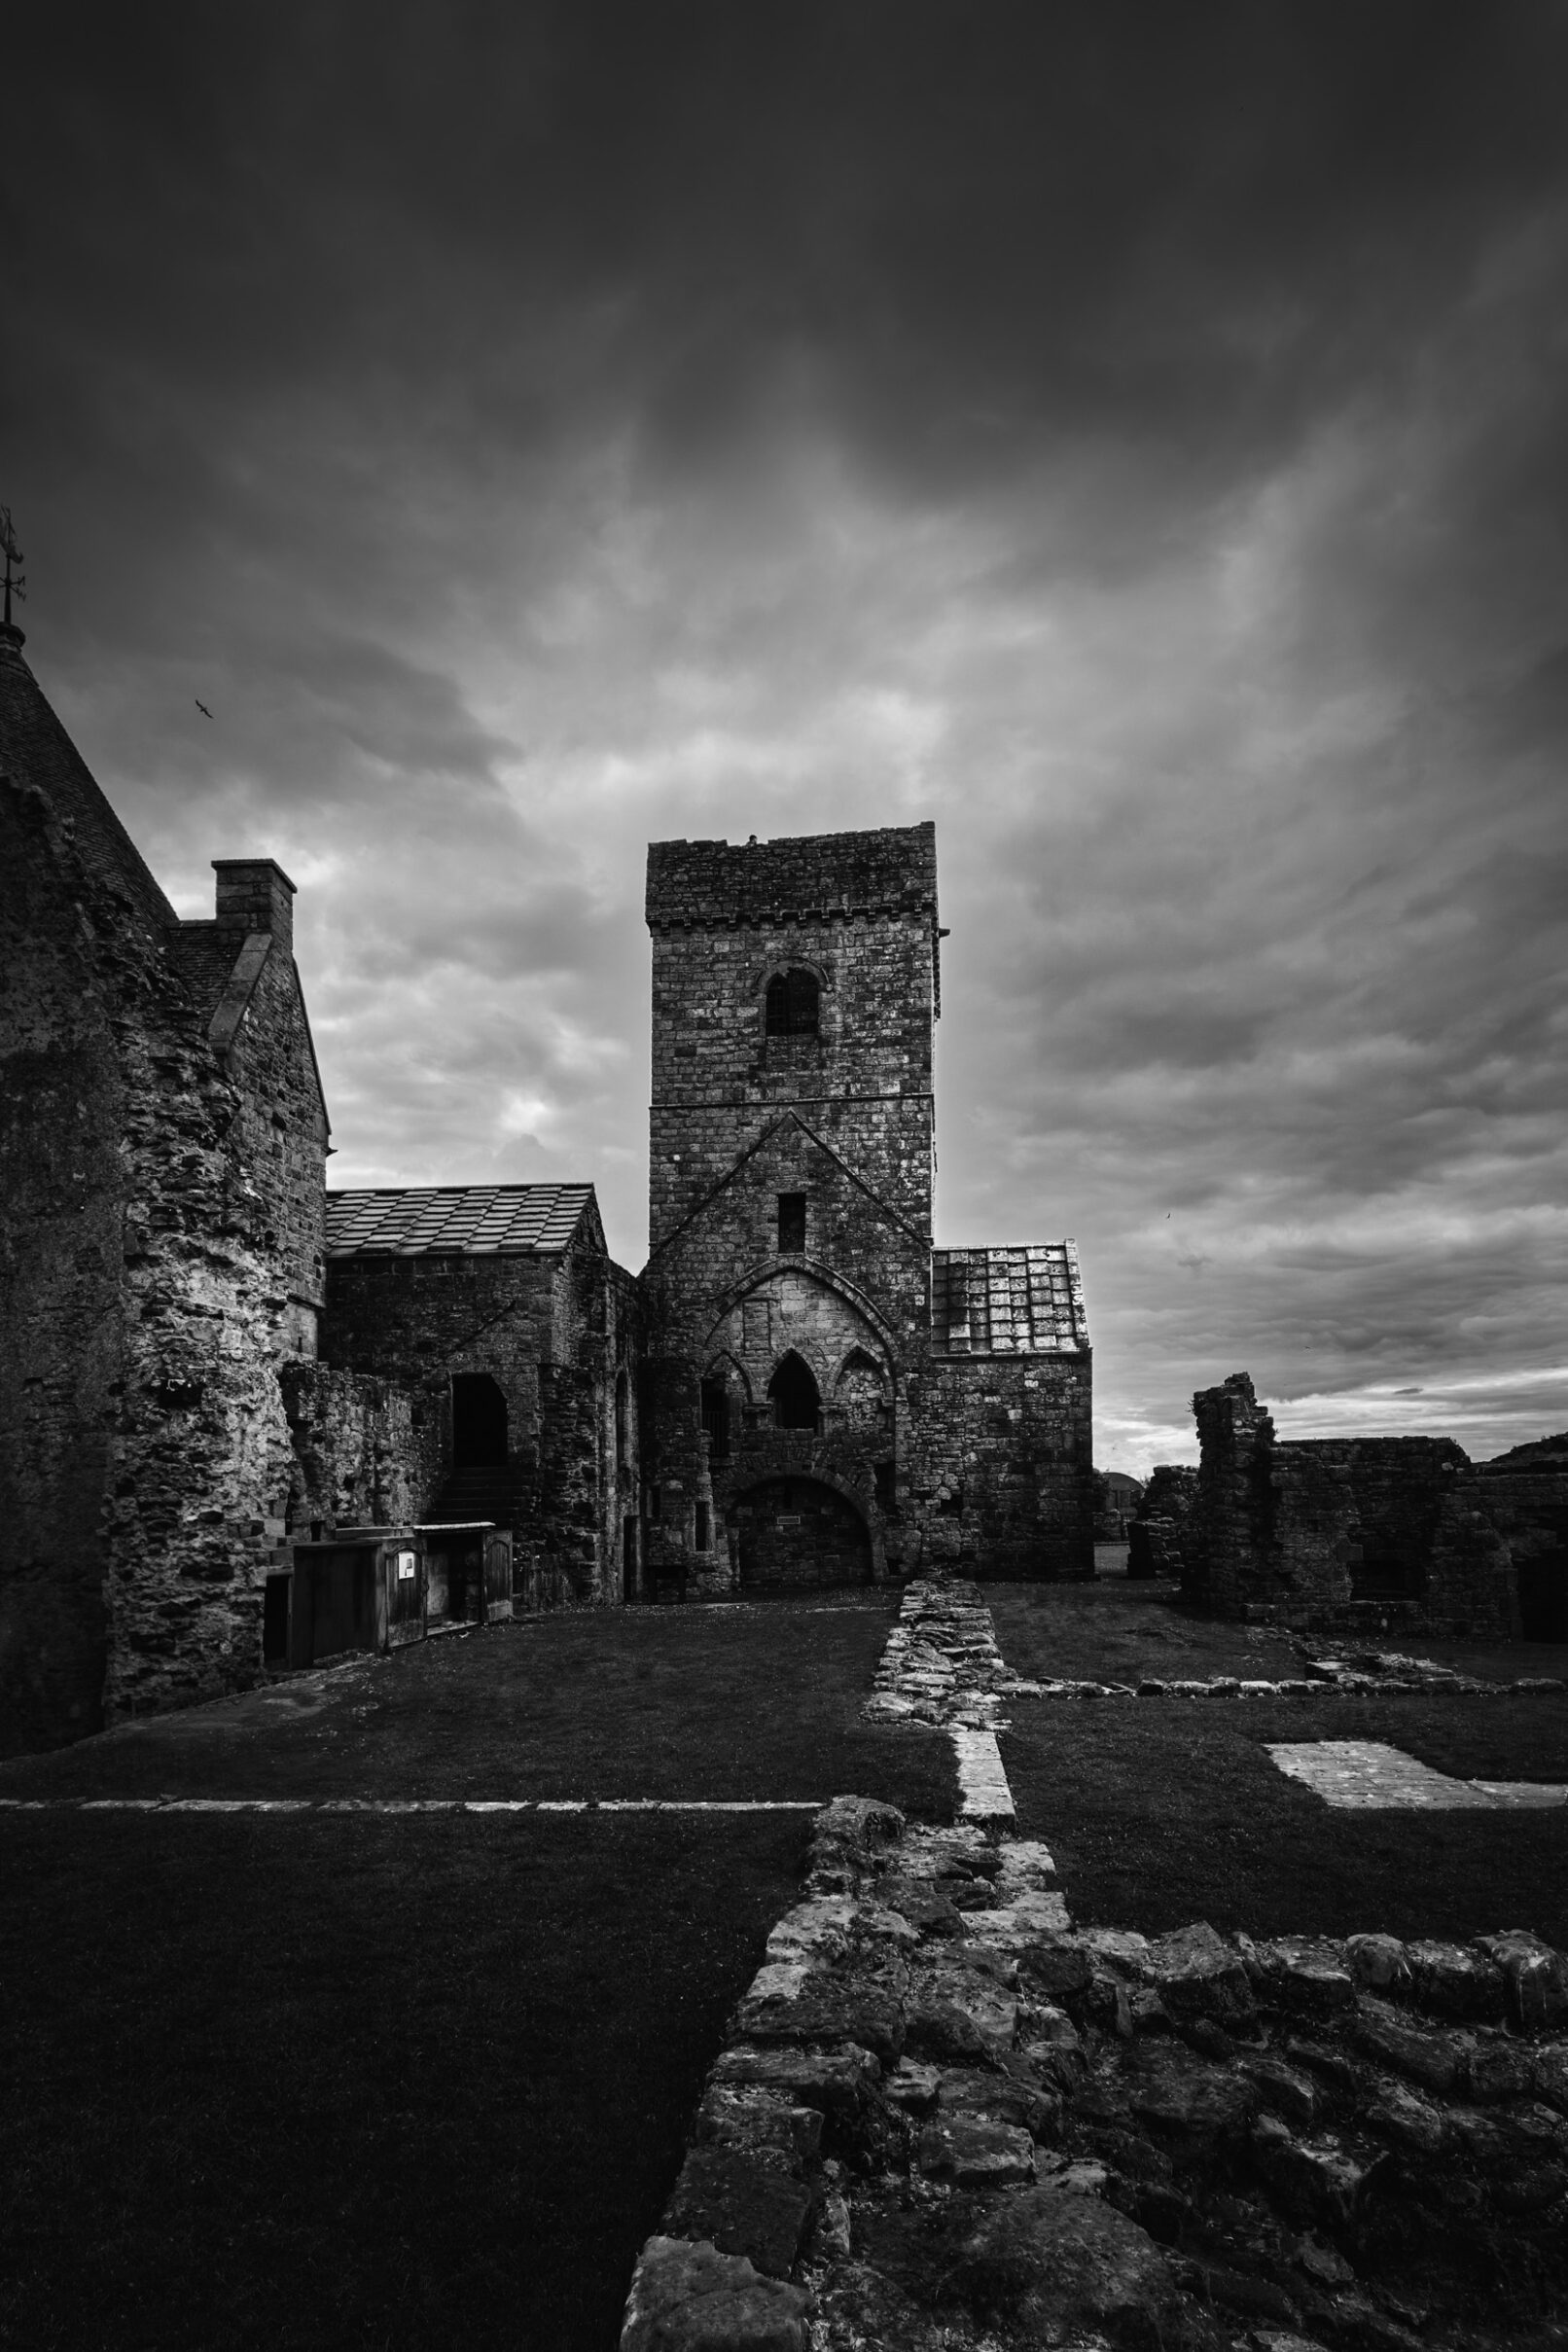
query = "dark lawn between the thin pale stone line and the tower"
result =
(0, 1597, 952, 1818)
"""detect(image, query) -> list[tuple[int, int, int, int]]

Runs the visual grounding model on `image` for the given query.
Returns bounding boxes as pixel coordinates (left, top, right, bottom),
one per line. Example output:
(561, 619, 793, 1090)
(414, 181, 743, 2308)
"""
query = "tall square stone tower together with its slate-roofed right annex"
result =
(642, 823, 1093, 1592)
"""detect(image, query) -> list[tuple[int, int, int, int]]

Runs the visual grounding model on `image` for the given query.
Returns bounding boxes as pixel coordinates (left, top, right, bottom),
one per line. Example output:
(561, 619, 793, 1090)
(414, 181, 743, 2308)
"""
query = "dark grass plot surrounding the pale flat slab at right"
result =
(1002, 1698, 1568, 1945)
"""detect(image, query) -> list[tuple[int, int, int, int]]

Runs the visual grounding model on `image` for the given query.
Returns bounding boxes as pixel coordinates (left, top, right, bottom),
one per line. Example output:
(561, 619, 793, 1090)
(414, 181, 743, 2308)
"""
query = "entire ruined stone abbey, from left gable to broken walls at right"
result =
(0, 624, 1568, 1752)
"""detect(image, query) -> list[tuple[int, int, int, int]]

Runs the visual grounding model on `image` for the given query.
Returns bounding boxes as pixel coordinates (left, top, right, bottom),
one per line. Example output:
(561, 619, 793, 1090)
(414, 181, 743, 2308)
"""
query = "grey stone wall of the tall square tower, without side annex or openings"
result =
(644, 826, 938, 1590)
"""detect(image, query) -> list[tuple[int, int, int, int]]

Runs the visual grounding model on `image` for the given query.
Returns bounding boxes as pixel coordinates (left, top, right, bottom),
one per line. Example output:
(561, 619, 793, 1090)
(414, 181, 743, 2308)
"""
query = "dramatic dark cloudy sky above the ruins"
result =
(0, 0, 1568, 1470)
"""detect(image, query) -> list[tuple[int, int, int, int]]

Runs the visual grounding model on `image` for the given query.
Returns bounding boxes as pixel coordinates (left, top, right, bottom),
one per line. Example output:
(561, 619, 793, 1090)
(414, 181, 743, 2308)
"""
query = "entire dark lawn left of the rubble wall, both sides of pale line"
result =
(0, 1597, 954, 2352)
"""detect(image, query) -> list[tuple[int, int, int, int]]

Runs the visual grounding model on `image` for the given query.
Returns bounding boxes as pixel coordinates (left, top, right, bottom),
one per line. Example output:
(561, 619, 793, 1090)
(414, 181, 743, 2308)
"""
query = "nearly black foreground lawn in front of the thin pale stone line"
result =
(0, 1813, 808, 2352)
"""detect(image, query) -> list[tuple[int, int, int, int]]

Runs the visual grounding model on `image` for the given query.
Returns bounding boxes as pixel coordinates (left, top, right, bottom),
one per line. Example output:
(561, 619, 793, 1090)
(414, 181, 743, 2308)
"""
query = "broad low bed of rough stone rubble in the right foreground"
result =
(621, 1787, 1568, 2352)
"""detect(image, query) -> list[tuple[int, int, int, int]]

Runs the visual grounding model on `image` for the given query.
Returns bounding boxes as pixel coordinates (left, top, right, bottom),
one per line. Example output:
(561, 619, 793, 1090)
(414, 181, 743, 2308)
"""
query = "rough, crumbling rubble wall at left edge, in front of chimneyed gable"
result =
(5, 762, 324, 1745)
